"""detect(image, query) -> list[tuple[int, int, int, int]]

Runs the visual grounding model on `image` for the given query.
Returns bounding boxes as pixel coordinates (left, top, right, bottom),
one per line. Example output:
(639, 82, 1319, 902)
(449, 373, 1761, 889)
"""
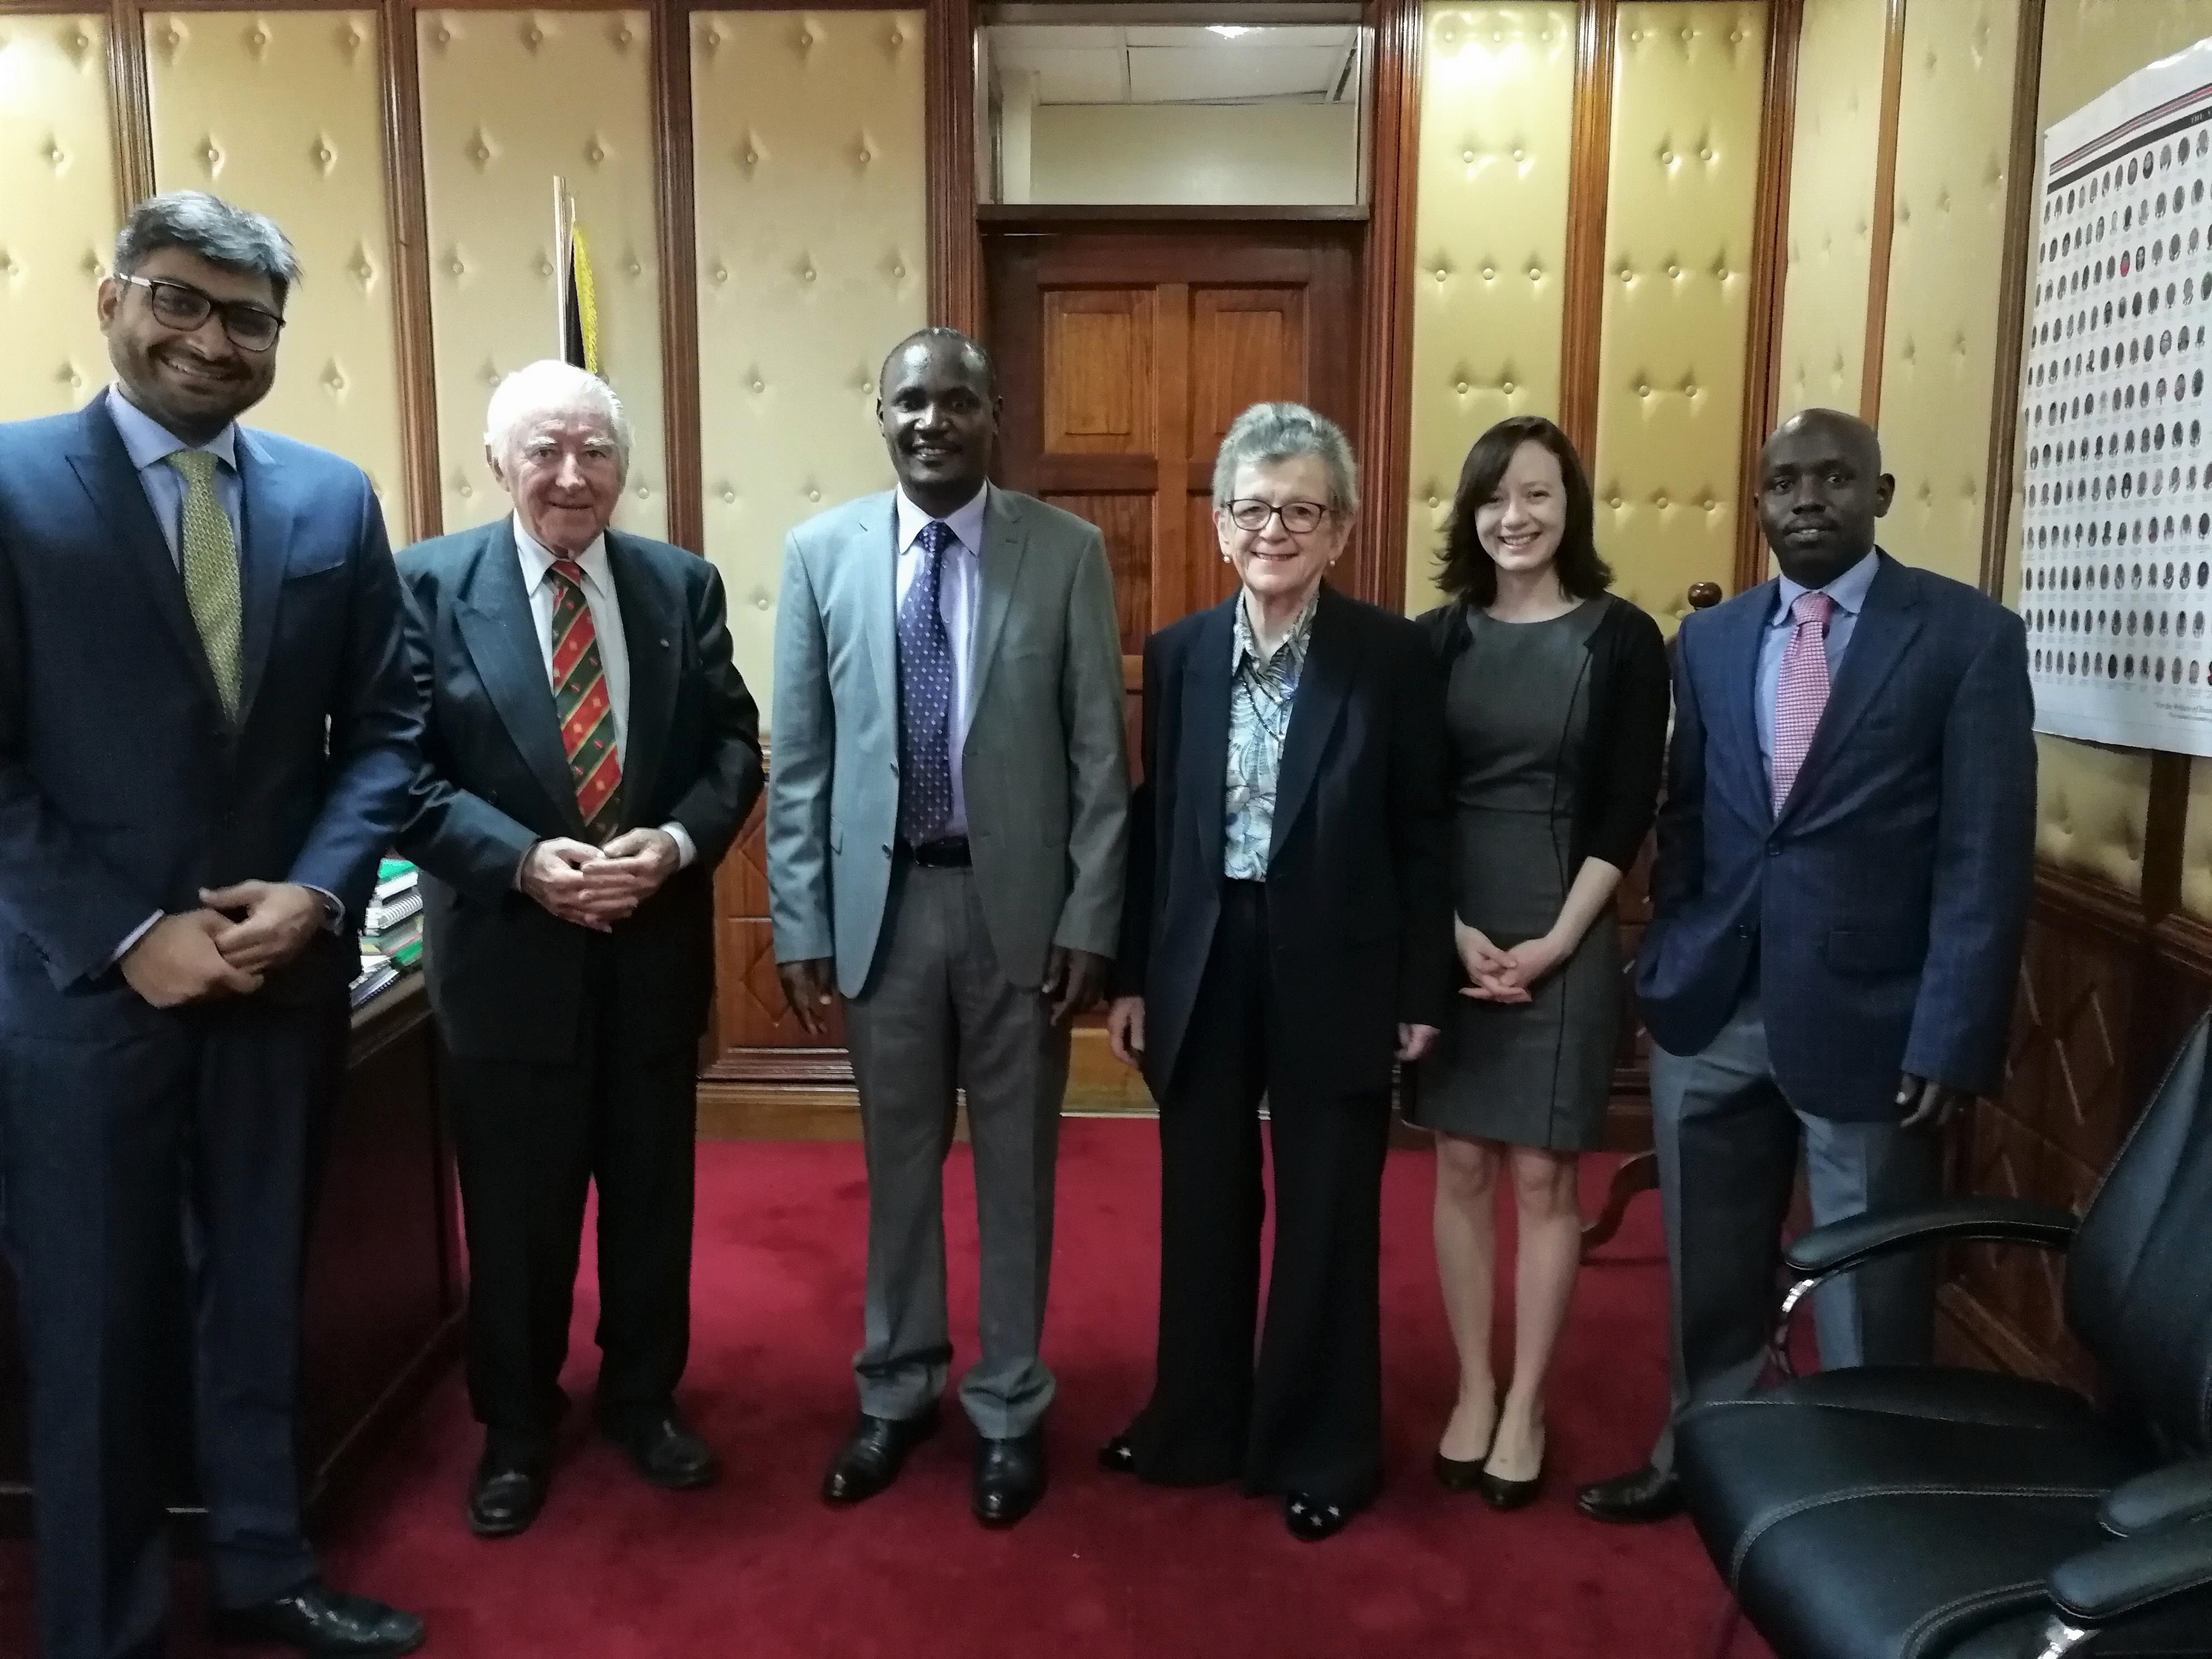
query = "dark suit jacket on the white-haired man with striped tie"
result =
(398, 518, 761, 1062)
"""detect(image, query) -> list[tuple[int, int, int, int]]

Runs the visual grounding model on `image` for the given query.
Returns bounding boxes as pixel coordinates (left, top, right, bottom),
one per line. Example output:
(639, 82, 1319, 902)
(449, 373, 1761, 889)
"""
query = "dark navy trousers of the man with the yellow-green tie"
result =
(0, 980, 345, 1659)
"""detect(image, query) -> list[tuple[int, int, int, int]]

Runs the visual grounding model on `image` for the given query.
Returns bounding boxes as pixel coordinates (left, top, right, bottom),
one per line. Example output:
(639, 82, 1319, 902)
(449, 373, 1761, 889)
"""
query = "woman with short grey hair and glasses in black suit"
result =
(1102, 402, 1451, 1540)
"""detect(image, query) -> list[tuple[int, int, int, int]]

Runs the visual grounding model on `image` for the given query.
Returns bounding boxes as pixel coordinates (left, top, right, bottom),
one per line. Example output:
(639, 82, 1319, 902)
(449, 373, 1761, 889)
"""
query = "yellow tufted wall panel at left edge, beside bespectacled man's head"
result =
(0, 16, 119, 420)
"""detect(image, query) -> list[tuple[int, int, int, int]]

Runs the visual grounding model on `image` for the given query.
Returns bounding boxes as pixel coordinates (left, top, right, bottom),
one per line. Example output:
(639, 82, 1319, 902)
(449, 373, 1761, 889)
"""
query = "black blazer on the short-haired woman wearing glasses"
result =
(1115, 586, 1453, 1097)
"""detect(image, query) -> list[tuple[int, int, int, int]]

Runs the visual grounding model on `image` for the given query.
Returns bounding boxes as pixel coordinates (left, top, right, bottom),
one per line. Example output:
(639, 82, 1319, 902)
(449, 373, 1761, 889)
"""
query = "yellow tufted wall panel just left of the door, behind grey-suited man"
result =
(690, 11, 929, 715)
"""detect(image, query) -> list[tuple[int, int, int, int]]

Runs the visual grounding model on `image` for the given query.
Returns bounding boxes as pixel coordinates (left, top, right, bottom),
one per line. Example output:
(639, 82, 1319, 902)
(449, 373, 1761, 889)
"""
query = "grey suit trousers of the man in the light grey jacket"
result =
(845, 863, 1069, 1440)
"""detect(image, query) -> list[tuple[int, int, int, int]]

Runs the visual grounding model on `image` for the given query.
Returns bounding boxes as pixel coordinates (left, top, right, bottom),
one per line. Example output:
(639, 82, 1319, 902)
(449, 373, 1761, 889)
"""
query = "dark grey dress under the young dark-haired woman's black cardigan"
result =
(1409, 595, 1622, 1152)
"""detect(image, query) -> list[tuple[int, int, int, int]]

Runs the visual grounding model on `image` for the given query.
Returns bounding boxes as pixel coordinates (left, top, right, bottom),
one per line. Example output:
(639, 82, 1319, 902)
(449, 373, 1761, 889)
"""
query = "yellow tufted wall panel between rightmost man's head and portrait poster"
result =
(1883, 0, 2020, 582)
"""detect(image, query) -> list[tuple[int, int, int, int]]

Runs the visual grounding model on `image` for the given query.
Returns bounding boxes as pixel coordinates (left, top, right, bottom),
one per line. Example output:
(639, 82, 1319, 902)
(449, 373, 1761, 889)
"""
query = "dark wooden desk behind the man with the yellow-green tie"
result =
(0, 973, 462, 1533)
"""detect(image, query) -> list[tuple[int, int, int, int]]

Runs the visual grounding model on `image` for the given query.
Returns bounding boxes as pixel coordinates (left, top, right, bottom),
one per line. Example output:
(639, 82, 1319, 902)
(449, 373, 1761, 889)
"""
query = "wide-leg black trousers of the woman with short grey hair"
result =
(1131, 880, 1389, 1508)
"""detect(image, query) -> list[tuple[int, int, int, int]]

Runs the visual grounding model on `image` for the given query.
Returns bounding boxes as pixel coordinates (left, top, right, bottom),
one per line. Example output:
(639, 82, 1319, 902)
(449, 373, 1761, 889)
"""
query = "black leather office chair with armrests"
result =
(1677, 1015, 2212, 1659)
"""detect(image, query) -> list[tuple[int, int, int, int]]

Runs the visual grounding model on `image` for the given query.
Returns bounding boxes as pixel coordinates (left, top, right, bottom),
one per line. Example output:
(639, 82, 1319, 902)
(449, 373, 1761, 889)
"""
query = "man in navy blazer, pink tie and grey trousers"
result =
(1582, 409, 2035, 1522)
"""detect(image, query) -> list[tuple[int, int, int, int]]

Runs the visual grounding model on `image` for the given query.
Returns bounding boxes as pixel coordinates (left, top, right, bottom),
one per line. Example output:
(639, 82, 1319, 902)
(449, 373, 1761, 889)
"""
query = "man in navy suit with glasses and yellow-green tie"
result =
(0, 192, 423, 1659)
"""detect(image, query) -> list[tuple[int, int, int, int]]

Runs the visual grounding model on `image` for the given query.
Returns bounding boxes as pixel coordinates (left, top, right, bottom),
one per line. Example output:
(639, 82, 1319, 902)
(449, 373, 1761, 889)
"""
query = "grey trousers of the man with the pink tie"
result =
(1652, 993, 1942, 1469)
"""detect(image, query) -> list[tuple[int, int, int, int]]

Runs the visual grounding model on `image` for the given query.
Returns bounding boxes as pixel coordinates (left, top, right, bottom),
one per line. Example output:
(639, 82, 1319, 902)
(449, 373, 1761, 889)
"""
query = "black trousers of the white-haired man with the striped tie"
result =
(447, 940, 699, 1458)
